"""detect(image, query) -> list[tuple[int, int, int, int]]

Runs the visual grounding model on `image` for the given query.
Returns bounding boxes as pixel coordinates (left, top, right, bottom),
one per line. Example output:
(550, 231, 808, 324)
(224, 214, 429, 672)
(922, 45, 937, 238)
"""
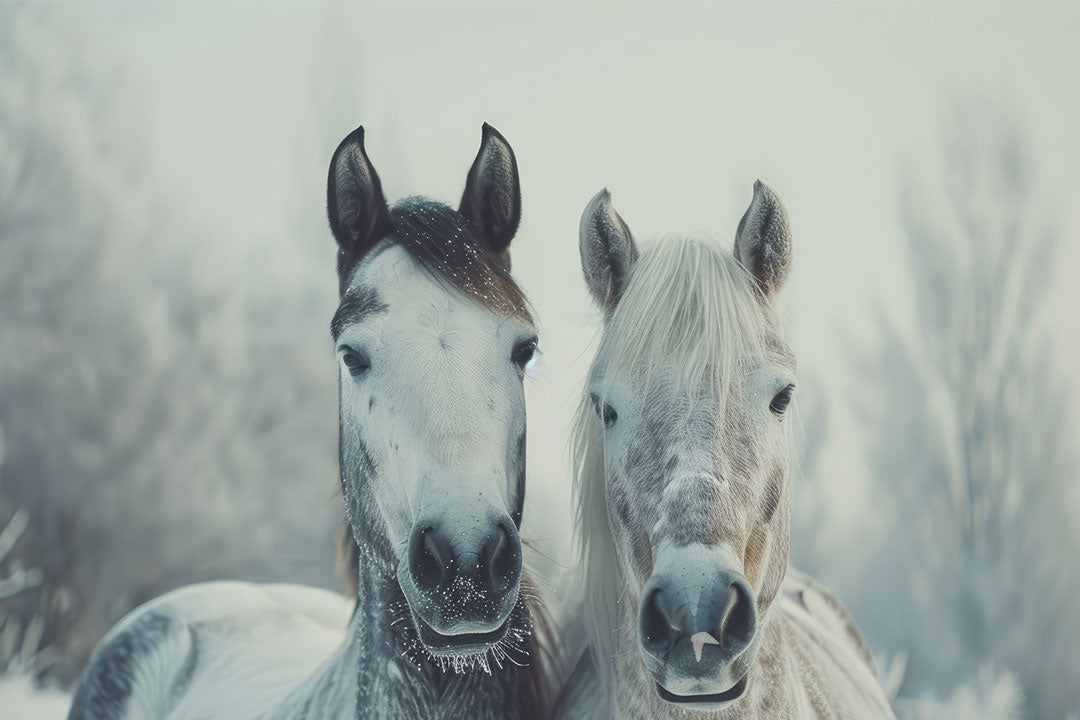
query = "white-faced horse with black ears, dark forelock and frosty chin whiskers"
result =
(69, 125, 546, 720)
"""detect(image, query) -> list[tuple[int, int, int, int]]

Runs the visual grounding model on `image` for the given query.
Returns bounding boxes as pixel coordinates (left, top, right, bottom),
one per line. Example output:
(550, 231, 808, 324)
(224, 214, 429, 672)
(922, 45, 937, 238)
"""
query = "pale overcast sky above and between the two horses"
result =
(53, 3, 1080, 553)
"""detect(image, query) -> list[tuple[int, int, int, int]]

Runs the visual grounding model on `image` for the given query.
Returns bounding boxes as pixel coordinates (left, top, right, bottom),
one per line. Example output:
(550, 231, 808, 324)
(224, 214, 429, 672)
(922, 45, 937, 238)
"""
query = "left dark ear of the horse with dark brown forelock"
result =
(326, 127, 390, 283)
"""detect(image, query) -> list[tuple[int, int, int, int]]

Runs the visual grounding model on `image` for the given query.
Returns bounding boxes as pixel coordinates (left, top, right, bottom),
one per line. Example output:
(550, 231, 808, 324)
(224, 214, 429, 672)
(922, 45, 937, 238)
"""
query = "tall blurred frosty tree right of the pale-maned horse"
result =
(847, 101, 1080, 720)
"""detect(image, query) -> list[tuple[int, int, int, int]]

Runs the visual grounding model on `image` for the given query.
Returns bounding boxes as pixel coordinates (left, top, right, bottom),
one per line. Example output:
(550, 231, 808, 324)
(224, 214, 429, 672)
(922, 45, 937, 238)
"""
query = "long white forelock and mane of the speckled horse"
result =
(571, 235, 769, 690)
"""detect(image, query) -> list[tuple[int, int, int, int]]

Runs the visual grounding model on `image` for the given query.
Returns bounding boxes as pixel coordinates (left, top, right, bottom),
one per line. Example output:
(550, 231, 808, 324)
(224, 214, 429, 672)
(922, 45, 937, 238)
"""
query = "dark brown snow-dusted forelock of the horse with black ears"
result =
(339, 196, 532, 325)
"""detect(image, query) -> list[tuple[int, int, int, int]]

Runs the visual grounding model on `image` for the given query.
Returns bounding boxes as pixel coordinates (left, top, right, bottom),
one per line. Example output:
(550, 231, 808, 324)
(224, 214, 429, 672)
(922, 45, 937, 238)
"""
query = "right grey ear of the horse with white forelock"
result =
(735, 180, 792, 300)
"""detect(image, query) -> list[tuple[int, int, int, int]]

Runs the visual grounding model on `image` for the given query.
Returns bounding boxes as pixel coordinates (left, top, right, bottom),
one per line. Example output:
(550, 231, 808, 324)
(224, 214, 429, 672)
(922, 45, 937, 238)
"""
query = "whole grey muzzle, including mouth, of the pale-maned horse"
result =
(638, 545, 757, 709)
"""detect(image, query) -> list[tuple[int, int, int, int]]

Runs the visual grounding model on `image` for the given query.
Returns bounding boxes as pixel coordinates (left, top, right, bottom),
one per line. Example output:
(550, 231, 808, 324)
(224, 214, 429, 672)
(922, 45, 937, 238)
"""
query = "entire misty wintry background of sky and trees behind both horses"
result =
(0, 2, 1080, 720)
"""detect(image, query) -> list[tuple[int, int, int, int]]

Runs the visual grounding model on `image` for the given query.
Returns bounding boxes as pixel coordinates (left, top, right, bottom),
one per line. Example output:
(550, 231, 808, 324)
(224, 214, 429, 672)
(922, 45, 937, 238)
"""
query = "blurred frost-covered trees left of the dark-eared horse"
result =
(0, 5, 340, 681)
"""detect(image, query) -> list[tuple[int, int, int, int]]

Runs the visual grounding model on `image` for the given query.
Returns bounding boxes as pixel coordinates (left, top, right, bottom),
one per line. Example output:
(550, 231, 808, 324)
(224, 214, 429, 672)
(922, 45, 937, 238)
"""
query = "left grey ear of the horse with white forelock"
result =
(578, 188, 637, 313)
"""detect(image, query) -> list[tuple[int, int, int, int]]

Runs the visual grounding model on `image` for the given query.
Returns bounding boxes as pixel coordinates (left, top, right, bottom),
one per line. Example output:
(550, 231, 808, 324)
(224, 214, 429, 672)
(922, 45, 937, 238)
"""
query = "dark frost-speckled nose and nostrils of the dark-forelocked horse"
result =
(408, 517, 522, 597)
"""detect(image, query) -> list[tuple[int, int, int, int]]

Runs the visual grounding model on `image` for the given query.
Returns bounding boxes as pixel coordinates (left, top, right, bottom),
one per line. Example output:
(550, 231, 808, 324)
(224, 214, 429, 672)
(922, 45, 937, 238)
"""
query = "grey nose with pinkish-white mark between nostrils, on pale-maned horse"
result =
(638, 572, 757, 663)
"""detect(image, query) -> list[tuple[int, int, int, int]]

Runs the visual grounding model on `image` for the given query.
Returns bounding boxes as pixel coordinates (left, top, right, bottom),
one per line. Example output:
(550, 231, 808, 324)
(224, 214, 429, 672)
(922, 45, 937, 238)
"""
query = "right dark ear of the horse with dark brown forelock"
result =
(459, 123, 522, 255)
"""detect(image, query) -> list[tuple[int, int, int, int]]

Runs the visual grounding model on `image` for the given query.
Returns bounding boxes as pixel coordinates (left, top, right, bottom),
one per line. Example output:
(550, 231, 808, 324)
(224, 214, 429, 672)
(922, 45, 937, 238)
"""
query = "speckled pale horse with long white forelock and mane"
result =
(557, 181, 893, 720)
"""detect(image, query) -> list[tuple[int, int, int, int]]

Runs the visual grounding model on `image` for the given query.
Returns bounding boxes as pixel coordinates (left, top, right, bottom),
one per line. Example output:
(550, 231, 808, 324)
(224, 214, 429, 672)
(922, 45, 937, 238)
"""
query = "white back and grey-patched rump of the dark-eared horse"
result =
(68, 582, 352, 720)
